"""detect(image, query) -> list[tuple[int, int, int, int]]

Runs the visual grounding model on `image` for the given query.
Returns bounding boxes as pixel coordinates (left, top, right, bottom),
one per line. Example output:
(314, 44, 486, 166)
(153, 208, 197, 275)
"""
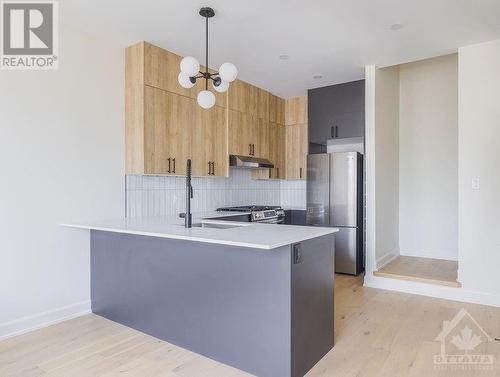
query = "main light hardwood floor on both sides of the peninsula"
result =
(0, 275, 500, 377)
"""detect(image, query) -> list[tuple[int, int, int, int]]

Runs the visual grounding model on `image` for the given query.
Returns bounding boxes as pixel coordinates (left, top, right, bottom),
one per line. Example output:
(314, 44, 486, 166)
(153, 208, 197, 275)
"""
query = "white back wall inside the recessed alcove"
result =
(399, 54, 458, 260)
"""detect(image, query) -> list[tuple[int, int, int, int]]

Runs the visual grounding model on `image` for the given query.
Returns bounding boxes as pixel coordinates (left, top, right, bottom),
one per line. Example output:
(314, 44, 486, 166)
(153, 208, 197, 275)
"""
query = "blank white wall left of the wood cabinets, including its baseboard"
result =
(0, 28, 125, 337)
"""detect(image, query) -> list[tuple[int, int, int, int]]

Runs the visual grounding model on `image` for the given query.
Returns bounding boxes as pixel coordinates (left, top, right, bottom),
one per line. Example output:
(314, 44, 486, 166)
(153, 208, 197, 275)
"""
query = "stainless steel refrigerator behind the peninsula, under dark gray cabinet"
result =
(306, 152, 364, 275)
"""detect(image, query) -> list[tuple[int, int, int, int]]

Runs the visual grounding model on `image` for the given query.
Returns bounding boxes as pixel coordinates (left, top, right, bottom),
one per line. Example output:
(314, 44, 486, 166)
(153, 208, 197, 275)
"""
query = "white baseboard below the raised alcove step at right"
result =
(364, 275, 500, 307)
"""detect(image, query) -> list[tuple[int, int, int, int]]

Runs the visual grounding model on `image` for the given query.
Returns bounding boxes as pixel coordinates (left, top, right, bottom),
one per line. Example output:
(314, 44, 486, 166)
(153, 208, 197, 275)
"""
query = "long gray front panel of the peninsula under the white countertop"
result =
(90, 231, 292, 377)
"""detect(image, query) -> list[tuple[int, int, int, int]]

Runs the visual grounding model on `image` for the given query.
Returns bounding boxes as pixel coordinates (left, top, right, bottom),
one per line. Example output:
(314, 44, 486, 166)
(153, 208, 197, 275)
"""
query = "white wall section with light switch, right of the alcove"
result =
(458, 40, 500, 301)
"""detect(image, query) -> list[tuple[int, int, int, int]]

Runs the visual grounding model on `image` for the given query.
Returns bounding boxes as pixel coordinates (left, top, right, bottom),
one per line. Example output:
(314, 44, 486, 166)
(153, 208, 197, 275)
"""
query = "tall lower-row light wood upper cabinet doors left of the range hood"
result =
(144, 86, 228, 176)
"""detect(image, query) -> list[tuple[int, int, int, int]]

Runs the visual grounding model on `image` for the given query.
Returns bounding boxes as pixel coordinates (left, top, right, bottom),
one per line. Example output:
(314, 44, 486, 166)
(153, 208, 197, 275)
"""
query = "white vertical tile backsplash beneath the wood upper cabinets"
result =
(126, 169, 306, 217)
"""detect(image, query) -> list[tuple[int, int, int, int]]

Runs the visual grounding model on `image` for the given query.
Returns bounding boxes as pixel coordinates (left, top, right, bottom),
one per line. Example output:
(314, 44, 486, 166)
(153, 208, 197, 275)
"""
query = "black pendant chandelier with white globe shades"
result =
(177, 7, 238, 109)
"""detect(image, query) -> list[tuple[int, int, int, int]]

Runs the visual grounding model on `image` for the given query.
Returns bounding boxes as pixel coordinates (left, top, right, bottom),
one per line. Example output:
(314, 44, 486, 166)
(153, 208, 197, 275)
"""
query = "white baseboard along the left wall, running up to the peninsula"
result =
(0, 300, 91, 340)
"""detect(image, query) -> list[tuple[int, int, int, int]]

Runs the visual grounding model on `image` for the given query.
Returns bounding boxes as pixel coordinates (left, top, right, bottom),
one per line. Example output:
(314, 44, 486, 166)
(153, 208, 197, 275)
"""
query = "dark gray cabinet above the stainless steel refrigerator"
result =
(308, 80, 365, 145)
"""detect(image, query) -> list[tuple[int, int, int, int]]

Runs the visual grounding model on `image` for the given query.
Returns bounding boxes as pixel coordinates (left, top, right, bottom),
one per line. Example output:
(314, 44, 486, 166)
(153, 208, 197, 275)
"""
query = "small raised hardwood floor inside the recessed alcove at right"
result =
(373, 255, 461, 287)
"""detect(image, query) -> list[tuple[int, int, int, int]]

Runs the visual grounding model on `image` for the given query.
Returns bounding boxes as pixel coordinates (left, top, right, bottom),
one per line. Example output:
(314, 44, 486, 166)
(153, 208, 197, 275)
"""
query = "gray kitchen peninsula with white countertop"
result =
(64, 214, 337, 377)
